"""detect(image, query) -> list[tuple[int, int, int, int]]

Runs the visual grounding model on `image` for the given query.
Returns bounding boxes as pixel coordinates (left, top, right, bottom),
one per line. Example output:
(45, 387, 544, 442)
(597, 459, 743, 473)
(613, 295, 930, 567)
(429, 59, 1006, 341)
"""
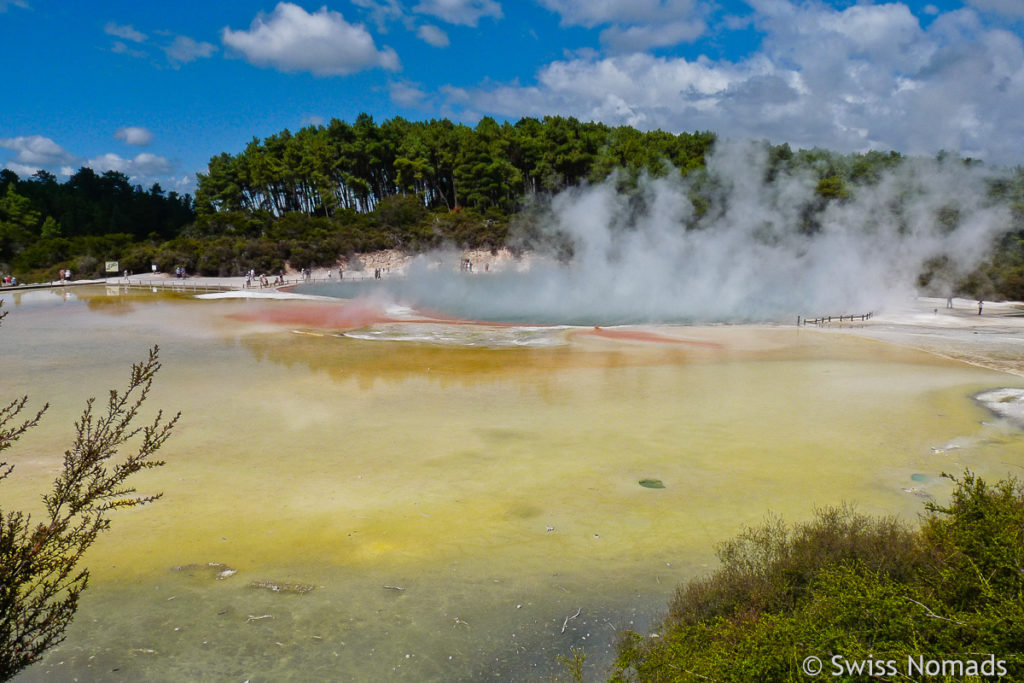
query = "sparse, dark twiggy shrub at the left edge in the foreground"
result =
(0, 302, 178, 681)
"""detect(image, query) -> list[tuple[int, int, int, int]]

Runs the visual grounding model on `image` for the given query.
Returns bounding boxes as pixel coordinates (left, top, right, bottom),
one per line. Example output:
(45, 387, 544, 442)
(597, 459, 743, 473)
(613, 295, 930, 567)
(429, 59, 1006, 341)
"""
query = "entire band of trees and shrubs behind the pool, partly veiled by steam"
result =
(6, 114, 1024, 299)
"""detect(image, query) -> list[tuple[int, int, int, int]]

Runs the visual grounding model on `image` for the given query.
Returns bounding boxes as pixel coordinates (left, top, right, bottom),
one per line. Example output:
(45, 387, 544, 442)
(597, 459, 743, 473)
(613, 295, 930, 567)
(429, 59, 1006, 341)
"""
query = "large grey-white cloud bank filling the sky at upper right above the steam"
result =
(442, 0, 1024, 164)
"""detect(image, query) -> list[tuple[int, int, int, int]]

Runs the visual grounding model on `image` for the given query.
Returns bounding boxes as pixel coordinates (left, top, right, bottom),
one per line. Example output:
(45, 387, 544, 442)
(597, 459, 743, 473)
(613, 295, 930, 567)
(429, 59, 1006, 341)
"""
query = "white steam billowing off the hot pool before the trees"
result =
(339, 142, 1011, 325)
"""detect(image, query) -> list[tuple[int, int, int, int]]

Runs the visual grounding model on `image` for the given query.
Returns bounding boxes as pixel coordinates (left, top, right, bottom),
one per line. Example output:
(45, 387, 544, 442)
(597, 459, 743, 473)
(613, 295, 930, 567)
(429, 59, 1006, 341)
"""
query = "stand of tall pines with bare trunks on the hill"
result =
(196, 114, 715, 217)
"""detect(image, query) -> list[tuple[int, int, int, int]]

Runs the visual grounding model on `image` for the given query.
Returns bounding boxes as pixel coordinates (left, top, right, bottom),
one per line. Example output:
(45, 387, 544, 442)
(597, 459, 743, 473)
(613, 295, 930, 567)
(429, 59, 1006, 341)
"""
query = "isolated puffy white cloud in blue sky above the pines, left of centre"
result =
(221, 2, 399, 76)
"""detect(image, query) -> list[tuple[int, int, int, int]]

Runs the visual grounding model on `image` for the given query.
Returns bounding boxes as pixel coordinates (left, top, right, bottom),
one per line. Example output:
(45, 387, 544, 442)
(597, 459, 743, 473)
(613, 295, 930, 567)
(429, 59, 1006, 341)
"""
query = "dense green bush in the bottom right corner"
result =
(612, 472, 1024, 681)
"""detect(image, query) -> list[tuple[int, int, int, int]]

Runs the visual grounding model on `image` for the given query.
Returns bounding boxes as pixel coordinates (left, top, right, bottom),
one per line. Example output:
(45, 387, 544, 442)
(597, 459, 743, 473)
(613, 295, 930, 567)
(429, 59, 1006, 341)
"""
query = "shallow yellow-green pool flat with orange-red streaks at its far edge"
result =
(0, 288, 1024, 683)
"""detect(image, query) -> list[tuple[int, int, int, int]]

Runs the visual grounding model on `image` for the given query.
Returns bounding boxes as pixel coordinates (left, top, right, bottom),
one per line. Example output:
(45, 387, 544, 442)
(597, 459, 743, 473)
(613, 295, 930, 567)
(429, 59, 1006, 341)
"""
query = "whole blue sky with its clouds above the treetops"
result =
(0, 0, 1024, 191)
